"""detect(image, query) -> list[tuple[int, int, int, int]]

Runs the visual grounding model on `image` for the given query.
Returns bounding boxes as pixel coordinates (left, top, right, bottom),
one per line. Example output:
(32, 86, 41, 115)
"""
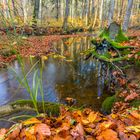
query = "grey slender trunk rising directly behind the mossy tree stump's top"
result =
(108, 0, 115, 26)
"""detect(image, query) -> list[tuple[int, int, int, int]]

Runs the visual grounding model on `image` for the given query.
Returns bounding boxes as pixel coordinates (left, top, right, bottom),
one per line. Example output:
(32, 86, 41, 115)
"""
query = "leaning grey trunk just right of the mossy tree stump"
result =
(122, 0, 133, 31)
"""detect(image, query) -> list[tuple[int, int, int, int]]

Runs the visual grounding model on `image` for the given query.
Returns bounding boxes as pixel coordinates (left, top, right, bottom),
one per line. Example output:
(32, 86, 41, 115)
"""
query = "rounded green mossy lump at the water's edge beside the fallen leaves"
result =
(102, 95, 116, 113)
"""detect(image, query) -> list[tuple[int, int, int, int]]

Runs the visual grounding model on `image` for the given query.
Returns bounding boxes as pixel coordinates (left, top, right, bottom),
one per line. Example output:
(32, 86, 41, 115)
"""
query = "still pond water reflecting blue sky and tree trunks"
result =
(0, 37, 108, 110)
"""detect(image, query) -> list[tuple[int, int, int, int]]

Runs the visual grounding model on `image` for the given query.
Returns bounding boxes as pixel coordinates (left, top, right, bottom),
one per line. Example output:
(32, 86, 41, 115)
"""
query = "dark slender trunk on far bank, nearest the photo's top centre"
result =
(63, 0, 70, 30)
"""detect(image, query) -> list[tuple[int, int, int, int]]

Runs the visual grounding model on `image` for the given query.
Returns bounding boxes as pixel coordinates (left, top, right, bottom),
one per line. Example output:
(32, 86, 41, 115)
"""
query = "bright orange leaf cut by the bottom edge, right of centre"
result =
(96, 129, 119, 140)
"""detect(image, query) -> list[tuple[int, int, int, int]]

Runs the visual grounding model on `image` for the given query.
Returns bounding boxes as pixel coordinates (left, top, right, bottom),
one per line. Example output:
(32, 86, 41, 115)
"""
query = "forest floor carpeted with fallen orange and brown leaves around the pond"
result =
(0, 30, 140, 140)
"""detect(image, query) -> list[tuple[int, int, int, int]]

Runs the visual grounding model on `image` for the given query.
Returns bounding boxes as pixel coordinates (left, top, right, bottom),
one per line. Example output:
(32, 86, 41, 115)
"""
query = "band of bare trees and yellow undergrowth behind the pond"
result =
(0, 0, 140, 31)
